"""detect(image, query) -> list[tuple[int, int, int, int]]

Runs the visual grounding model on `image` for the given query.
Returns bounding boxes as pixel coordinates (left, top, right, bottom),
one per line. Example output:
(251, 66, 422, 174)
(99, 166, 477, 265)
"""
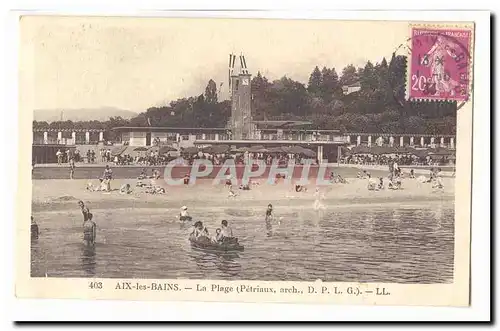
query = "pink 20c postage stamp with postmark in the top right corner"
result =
(408, 26, 472, 102)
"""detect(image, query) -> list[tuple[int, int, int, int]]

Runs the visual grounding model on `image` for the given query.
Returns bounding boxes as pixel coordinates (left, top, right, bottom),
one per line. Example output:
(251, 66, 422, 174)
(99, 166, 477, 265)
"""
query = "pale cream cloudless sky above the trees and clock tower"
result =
(20, 16, 409, 112)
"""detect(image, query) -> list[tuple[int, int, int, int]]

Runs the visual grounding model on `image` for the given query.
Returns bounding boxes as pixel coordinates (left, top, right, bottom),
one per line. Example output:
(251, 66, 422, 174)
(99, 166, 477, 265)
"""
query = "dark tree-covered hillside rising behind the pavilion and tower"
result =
(34, 55, 457, 134)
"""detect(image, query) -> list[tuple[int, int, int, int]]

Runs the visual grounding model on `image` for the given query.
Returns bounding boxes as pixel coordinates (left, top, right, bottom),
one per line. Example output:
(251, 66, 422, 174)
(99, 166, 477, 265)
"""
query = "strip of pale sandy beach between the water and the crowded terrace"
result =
(32, 178, 455, 214)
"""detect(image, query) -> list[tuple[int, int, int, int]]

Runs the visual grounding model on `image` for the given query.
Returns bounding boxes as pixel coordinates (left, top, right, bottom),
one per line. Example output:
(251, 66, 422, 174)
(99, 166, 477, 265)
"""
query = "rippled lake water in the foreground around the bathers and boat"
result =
(31, 202, 454, 283)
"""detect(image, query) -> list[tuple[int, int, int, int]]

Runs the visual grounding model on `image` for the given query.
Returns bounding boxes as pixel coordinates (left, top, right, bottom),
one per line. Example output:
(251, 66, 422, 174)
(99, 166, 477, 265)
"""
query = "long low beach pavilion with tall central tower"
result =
(114, 70, 347, 162)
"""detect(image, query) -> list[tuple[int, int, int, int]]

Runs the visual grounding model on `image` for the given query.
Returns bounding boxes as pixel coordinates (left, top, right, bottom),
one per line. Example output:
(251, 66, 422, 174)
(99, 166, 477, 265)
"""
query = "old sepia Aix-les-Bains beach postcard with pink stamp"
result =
(16, 14, 475, 306)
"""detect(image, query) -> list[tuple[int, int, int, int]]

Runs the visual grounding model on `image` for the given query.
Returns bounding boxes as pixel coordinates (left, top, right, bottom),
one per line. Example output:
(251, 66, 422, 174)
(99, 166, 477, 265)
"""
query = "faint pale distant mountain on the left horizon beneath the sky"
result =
(33, 107, 138, 122)
